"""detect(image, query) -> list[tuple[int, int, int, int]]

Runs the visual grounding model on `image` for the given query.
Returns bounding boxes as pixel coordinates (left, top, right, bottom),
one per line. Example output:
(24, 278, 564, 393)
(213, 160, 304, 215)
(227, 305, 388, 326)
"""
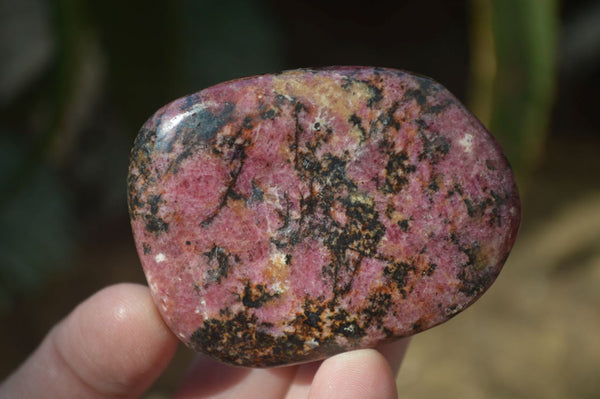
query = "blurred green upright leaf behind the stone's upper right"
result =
(470, 0, 558, 183)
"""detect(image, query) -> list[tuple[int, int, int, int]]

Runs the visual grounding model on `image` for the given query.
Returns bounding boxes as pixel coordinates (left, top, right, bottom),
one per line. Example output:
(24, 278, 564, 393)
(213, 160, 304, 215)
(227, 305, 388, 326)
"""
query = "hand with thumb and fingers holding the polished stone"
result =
(0, 284, 408, 399)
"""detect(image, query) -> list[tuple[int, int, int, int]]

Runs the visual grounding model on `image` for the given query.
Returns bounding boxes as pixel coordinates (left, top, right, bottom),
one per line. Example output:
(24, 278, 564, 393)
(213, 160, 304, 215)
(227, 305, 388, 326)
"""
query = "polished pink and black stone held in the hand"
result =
(128, 67, 520, 367)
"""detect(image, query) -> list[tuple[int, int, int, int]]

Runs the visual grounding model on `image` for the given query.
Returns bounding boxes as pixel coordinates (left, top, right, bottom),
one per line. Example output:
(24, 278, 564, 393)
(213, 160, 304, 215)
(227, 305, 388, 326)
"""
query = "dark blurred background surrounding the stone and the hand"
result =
(0, 0, 600, 399)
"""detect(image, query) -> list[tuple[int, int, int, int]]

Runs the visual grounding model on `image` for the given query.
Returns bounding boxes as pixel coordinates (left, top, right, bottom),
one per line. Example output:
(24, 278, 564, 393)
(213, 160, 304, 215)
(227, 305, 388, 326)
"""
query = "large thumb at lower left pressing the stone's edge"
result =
(0, 284, 178, 398)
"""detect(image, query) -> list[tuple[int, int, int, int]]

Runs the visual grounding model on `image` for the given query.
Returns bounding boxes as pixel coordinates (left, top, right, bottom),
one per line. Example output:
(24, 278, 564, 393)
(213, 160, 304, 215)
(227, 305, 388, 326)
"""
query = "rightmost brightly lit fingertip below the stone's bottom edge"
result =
(308, 349, 398, 399)
